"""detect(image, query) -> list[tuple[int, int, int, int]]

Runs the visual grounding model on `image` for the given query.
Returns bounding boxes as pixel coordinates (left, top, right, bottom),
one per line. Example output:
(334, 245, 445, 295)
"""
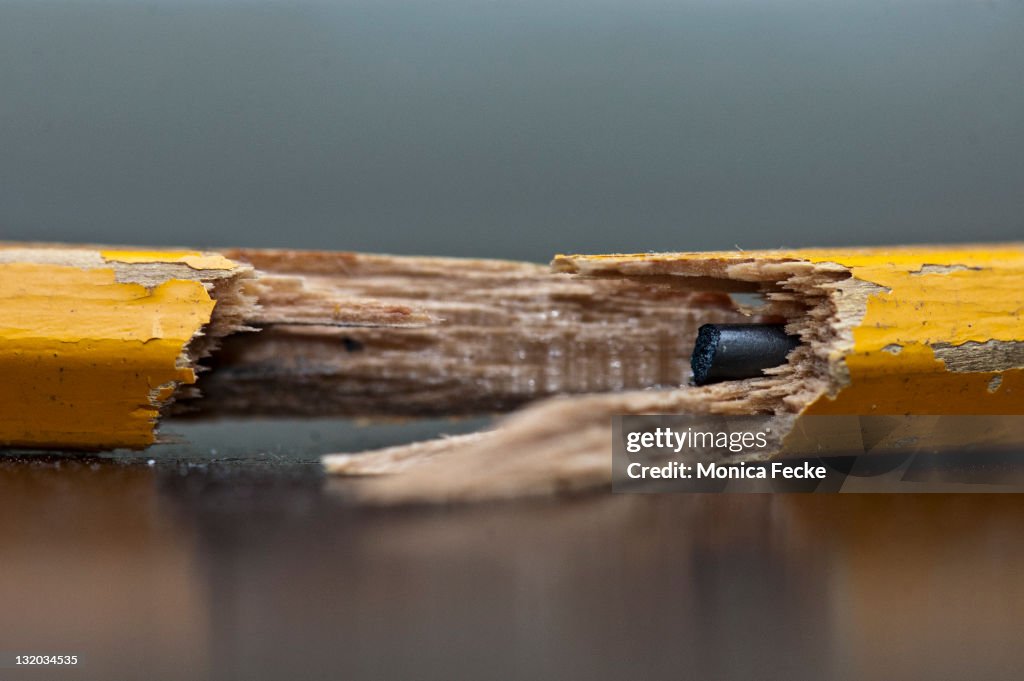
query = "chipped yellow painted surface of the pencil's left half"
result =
(0, 262, 214, 449)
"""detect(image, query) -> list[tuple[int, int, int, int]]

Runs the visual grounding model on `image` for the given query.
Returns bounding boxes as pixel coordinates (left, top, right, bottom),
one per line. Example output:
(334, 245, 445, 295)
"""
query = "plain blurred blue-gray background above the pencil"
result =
(0, 0, 1024, 261)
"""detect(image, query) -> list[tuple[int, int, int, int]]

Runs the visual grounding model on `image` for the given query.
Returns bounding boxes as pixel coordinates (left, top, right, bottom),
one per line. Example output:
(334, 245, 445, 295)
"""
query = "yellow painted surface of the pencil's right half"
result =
(556, 244, 1024, 415)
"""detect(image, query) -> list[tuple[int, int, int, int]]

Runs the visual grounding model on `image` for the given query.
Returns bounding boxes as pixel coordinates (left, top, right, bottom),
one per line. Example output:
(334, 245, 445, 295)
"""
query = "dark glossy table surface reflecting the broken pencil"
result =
(0, 423, 1024, 680)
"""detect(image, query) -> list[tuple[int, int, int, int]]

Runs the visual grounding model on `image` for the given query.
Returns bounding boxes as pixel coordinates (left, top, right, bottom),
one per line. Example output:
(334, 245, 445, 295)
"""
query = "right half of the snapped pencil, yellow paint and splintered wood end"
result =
(324, 245, 1024, 503)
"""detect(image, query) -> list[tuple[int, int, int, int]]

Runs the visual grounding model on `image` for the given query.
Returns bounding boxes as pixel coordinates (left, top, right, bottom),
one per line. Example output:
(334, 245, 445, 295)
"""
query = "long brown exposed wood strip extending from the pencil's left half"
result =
(190, 251, 767, 417)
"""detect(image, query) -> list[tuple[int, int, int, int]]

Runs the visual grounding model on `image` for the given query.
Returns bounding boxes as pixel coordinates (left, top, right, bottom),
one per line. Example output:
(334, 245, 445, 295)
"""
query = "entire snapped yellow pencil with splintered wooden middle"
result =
(0, 244, 1024, 499)
